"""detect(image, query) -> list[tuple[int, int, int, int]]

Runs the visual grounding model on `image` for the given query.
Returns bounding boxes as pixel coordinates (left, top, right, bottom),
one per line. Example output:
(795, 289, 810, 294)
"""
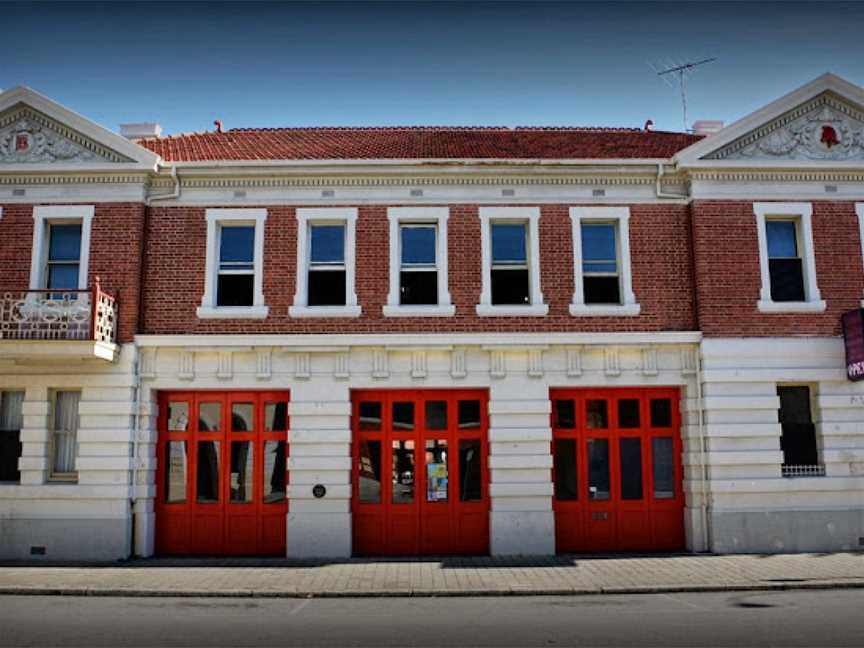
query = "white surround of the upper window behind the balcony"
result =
(30, 205, 96, 292)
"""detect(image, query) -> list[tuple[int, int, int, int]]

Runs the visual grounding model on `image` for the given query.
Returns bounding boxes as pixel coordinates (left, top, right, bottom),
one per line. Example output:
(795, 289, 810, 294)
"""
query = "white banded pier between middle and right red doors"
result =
(489, 373, 555, 555)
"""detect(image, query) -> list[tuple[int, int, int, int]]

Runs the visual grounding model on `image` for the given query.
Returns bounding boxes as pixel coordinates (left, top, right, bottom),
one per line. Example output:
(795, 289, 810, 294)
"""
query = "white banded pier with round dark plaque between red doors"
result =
(287, 374, 351, 558)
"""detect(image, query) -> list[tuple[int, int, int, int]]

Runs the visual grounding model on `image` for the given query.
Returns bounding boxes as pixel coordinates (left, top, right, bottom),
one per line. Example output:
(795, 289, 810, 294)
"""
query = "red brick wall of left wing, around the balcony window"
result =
(0, 203, 145, 342)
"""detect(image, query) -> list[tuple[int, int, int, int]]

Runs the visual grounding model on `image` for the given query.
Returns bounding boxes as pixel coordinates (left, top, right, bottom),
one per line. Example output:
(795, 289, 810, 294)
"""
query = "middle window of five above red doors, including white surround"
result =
(383, 207, 456, 317)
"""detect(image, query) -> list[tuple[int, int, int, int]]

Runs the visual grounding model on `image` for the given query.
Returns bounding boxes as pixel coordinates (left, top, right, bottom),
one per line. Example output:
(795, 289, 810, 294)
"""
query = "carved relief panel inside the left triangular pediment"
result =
(0, 115, 116, 164)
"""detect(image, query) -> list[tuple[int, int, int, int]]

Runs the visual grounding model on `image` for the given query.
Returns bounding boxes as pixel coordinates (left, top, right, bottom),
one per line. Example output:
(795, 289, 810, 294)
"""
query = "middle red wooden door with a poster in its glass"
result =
(352, 390, 489, 555)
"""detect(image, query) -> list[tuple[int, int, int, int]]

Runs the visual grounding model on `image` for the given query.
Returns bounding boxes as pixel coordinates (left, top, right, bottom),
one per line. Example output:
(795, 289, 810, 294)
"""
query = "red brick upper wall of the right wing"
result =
(691, 201, 864, 337)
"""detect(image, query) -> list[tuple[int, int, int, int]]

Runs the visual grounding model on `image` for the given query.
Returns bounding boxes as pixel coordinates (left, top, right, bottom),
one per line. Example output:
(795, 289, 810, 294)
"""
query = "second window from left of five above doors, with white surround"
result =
(288, 207, 361, 317)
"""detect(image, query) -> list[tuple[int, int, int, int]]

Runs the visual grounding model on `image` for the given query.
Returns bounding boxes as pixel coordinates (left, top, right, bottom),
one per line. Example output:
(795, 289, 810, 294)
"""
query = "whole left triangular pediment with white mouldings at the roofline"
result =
(0, 105, 133, 164)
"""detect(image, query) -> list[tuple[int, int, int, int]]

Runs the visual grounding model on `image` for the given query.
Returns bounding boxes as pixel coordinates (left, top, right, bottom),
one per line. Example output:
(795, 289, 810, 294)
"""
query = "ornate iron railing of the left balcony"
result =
(0, 277, 117, 342)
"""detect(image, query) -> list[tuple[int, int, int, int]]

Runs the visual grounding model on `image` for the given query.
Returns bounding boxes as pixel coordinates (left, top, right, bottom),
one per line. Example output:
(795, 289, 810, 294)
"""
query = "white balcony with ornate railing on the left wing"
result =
(0, 278, 117, 362)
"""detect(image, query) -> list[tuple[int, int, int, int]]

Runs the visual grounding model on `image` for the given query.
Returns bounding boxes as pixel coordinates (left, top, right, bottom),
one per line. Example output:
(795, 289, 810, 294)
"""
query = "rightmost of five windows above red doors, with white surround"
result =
(570, 207, 641, 317)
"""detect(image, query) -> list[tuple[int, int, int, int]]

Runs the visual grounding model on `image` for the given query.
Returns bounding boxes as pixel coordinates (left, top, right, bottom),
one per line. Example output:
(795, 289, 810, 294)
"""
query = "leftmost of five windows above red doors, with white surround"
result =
(198, 208, 268, 319)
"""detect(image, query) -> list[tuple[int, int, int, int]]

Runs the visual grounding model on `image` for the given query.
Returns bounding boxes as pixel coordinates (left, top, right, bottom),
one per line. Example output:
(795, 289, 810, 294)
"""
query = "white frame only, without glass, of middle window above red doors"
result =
(382, 207, 456, 317)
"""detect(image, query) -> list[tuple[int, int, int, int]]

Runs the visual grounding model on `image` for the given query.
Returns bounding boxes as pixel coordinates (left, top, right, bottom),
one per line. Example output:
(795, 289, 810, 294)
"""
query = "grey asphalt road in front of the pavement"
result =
(0, 589, 864, 648)
